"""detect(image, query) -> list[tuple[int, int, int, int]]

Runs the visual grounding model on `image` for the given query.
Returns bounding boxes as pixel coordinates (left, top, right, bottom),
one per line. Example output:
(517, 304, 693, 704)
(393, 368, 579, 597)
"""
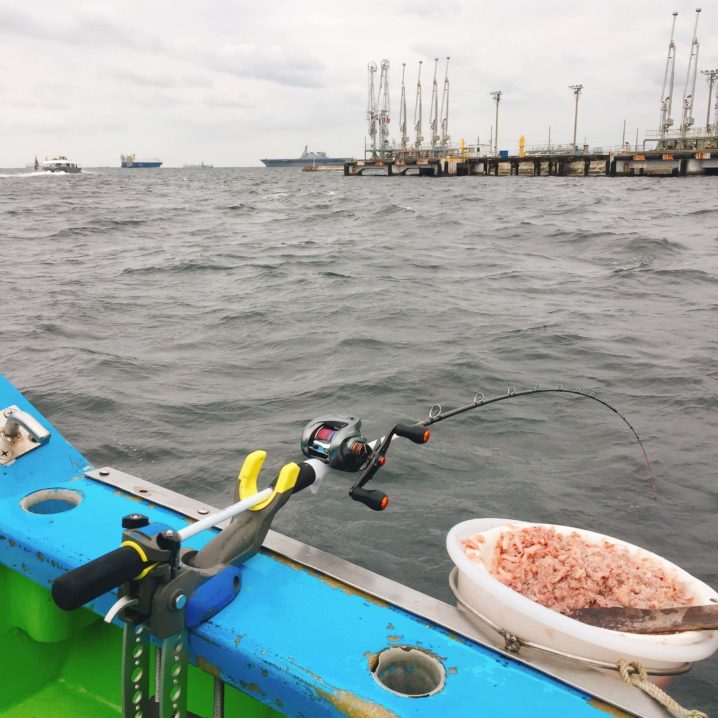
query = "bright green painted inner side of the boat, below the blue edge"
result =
(0, 565, 282, 718)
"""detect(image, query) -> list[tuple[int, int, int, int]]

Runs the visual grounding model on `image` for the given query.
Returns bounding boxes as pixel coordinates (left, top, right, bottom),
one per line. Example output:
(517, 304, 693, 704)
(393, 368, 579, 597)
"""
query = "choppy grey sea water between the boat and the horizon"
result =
(0, 168, 718, 714)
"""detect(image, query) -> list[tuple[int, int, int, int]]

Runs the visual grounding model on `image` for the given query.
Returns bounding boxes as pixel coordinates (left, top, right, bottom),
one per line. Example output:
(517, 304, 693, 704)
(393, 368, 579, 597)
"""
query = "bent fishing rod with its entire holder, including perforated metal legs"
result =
(52, 386, 652, 718)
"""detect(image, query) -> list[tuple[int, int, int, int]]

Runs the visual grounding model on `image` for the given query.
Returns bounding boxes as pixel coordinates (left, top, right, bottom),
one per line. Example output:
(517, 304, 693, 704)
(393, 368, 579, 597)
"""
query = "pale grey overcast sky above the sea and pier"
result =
(0, 0, 718, 167)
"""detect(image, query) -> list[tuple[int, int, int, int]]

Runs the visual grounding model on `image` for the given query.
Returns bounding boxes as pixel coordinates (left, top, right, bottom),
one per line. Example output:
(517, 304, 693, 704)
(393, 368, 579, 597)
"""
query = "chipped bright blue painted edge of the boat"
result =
(0, 376, 656, 718)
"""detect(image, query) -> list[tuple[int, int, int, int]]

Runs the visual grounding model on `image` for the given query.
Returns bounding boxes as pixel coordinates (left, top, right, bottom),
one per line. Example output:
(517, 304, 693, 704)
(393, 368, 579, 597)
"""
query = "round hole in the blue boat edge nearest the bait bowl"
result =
(371, 646, 446, 698)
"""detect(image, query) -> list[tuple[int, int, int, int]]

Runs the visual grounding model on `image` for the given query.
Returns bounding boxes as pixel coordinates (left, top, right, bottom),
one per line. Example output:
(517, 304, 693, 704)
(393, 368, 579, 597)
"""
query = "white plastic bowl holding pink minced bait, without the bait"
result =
(446, 518, 718, 670)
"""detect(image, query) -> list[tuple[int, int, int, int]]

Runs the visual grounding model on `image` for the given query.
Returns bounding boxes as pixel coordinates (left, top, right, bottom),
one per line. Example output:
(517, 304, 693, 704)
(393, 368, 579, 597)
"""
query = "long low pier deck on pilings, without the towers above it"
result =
(344, 150, 718, 177)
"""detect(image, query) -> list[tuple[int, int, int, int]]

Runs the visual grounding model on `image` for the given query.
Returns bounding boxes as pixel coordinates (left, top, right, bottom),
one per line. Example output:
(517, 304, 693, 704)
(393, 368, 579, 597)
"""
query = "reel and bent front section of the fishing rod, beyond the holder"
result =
(301, 385, 655, 511)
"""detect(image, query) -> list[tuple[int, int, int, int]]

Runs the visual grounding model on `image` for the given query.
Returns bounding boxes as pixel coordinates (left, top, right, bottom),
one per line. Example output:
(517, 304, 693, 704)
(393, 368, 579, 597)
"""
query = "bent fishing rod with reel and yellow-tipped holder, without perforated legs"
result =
(52, 386, 653, 620)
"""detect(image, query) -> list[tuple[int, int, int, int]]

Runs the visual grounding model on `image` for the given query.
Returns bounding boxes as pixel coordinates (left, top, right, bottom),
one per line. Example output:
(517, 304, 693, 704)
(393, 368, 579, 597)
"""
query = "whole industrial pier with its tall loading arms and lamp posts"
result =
(358, 8, 718, 183)
